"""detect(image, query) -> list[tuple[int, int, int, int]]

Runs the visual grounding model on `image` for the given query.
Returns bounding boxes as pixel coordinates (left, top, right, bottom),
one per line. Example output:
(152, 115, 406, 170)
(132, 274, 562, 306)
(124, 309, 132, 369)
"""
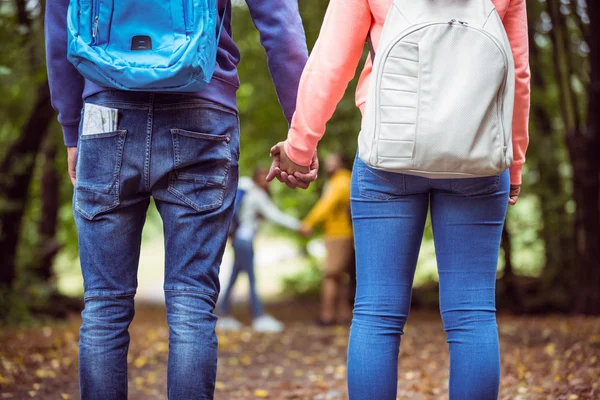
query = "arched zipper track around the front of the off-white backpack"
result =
(373, 19, 508, 153)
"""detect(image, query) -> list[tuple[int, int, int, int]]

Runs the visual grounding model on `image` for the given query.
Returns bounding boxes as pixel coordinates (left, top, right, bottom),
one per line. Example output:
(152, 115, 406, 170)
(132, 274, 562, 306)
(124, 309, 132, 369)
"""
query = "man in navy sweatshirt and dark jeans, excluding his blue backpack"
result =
(45, 0, 308, 400)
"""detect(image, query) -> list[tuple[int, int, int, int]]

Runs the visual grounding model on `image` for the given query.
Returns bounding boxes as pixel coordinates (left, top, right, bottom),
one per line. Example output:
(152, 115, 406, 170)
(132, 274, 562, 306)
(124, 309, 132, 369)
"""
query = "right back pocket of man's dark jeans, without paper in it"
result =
(168, 129, 231, 212)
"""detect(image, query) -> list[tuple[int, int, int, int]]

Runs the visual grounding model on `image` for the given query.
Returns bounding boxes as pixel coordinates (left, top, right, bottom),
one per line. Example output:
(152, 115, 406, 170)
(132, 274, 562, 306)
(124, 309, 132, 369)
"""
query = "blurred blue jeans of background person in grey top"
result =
(220, 236, 263, 318)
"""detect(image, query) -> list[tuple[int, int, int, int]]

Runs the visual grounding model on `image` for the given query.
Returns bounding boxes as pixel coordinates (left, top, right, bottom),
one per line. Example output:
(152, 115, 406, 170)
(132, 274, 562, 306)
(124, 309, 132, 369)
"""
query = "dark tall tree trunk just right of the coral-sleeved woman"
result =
(527, 2, 575, 310)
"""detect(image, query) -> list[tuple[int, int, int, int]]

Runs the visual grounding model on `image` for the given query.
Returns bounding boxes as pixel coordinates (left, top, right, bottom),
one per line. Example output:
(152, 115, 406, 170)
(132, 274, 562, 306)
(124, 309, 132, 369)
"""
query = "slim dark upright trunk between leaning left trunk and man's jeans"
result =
(37, 131, 60, 282)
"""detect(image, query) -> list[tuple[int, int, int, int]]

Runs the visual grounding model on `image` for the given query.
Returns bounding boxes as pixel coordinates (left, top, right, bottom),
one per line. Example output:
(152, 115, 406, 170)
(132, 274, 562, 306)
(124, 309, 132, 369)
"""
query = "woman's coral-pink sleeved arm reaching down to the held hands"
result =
(284, 0, 372, 166)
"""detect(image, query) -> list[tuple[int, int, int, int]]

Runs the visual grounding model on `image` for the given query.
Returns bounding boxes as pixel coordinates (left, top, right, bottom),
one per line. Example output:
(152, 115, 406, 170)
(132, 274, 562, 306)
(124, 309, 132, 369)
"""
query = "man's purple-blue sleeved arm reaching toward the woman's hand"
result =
(246, 0, 308, 123)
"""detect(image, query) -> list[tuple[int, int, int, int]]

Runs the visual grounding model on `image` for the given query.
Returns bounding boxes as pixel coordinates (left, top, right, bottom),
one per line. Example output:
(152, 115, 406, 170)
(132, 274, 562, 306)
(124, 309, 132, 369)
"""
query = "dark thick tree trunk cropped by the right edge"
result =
(567, 0, 600, 314)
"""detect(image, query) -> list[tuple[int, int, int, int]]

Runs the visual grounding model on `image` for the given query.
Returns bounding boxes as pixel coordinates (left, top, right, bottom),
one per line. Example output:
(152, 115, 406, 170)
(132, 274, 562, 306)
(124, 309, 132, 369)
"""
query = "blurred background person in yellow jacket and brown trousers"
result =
(300, 153, 354, 326)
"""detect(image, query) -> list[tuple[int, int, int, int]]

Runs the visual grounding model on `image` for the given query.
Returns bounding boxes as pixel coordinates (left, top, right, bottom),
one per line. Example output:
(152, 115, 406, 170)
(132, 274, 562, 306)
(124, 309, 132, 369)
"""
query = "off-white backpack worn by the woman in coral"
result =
(359, 0, 515, 178)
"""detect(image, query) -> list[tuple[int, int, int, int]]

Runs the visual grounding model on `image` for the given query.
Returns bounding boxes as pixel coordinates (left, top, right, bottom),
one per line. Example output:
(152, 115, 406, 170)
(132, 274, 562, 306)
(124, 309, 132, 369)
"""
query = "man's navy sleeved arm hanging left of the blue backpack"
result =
(44, 0, 84, 147)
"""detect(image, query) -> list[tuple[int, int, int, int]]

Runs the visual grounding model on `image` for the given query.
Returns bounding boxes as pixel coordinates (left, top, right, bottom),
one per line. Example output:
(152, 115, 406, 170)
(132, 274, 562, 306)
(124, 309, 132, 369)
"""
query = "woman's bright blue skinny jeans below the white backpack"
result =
(348, 158, 509, 400)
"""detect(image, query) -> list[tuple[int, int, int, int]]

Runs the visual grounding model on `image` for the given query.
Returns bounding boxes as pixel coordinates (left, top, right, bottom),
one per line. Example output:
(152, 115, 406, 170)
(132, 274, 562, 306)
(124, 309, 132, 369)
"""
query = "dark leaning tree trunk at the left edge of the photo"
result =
(0, 81, 54, 289)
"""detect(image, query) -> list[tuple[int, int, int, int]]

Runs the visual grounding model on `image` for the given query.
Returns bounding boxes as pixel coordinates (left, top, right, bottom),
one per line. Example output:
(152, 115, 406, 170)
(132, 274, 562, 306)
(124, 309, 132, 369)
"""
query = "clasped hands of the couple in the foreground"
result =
(267, 142, 319, 189)
